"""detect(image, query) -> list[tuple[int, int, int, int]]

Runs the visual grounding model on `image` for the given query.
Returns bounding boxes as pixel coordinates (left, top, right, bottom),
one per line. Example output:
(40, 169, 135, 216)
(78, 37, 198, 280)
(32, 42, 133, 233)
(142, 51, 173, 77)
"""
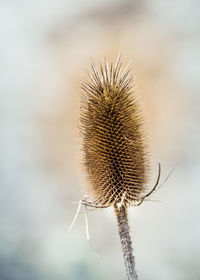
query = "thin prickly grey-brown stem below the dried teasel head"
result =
(115, 206, 138, 280)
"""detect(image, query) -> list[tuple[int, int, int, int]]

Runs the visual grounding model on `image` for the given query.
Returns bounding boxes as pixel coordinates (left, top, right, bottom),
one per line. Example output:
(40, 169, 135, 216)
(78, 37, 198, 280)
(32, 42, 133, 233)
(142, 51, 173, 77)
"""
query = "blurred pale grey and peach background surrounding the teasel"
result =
(0, 0, 200, 280)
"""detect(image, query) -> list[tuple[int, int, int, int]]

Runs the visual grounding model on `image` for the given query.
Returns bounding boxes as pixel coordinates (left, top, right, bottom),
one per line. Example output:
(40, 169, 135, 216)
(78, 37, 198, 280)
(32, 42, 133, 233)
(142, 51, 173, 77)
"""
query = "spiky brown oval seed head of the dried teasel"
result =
(81, 58, 148, 207)
